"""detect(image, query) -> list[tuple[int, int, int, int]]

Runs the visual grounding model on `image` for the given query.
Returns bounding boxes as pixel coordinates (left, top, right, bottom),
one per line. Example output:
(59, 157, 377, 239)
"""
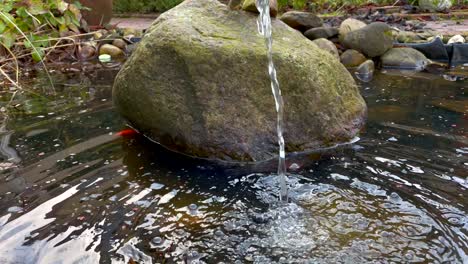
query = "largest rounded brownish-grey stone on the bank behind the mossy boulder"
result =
(343, 22, 393, 58)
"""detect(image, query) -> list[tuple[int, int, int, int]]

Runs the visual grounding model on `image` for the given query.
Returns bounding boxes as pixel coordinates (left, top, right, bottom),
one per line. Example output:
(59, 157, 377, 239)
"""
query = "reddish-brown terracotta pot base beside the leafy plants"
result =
(79, 0, 113, 26)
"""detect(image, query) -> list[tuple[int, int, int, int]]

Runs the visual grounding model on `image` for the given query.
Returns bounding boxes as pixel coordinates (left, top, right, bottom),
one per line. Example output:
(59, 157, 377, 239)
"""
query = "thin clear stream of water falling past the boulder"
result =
(256, 0, 288, 201)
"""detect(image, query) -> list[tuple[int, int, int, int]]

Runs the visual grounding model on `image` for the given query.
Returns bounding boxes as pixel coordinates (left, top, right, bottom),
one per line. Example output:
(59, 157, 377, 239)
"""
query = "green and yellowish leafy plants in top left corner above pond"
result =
(0, 0, 84, 61)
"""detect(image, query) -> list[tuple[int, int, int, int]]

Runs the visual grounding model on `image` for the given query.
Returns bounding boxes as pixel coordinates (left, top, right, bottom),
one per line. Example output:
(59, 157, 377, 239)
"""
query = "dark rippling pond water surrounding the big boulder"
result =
(0, 71, 468, 263)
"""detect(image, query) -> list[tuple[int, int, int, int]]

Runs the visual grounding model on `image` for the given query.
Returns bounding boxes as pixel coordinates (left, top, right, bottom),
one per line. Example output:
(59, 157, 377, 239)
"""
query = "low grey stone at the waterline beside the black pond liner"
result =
(381, 48, 429, 71)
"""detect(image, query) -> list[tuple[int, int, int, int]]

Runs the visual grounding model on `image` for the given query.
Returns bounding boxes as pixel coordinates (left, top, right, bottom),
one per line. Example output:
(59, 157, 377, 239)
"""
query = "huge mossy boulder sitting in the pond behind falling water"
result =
(113, 0, 366, 161)
